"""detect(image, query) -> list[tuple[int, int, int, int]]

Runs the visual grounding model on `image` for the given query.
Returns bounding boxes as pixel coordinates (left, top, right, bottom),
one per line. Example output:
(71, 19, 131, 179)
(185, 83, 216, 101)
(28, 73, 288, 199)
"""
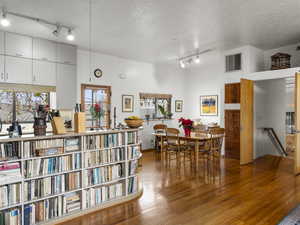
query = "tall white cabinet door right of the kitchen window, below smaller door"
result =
(56, 64, 77, 109)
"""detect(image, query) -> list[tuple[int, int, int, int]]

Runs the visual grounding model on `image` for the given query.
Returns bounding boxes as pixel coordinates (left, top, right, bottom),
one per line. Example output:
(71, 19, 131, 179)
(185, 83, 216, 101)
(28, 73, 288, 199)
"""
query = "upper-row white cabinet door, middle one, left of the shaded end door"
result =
(33, 38, 57, 62)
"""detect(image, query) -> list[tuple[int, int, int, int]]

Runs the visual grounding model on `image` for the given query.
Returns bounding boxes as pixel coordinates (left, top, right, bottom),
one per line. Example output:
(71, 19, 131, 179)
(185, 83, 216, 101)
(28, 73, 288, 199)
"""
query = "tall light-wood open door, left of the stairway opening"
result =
(240, 79, 254, 165)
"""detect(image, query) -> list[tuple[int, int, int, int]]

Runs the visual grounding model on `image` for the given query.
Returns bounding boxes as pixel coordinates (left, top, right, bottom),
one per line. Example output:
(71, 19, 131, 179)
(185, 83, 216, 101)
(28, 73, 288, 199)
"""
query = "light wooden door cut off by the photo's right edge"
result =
(294, 73, 300, 175)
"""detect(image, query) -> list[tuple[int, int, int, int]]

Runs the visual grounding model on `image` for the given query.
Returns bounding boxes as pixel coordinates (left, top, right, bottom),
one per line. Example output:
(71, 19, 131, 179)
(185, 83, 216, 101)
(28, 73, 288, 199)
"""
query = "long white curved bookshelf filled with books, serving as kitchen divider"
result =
(0, 129, 142, 225)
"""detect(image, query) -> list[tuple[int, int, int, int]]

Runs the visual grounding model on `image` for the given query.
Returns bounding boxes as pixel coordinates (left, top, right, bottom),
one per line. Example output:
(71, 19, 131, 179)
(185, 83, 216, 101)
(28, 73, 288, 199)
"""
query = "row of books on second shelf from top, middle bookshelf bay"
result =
(24, 153, 81, 178)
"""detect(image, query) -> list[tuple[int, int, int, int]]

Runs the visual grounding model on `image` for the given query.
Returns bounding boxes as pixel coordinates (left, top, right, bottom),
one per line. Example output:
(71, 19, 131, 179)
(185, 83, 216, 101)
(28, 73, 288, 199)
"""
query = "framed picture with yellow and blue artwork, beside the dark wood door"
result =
(200, 95, 218, 116)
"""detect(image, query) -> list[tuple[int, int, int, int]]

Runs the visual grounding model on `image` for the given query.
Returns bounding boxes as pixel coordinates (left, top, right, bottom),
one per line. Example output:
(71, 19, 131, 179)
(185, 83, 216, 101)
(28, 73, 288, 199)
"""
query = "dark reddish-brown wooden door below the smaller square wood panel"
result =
(225, 110, 240, 159)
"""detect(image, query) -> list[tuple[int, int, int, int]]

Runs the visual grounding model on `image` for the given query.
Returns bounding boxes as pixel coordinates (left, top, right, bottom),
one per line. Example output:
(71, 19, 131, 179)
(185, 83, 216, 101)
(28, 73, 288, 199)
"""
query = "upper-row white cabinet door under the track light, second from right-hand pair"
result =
(5, 33, 32, 58)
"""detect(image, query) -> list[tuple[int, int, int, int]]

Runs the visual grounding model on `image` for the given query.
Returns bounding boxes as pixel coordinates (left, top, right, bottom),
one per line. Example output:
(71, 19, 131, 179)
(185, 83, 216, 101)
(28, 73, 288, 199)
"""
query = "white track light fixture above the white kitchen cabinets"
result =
(0, 8, 75, 41)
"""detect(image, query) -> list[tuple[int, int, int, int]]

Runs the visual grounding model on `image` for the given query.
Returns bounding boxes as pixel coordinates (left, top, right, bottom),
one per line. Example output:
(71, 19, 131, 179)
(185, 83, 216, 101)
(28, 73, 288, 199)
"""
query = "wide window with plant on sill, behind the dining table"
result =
(140, 93, 172, 119)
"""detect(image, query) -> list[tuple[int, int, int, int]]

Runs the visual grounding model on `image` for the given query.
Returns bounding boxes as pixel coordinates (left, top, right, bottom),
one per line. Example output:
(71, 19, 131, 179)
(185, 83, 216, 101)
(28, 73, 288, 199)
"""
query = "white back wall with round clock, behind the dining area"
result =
(77, 50, 186, 149)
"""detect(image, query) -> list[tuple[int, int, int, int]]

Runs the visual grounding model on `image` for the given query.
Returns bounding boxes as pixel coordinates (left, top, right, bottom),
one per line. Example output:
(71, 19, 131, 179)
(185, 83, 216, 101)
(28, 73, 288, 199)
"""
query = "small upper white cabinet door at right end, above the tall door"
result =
(57, 43, 77, 65)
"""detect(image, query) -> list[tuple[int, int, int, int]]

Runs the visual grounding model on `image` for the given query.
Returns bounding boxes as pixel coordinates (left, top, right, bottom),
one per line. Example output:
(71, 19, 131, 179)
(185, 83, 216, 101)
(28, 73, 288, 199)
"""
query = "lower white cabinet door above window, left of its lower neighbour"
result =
(5, 56, 32, 84)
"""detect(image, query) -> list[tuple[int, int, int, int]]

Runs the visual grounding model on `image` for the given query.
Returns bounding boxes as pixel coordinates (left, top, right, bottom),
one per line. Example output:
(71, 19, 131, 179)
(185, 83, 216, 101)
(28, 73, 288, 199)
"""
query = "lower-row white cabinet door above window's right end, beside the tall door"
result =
(33, 60, 56, 86)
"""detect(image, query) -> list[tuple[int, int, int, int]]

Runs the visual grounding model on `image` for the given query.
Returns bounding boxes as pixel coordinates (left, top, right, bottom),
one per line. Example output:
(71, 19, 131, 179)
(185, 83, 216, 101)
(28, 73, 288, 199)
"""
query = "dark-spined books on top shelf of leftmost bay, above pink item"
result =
(0, 142, 21, 161)
